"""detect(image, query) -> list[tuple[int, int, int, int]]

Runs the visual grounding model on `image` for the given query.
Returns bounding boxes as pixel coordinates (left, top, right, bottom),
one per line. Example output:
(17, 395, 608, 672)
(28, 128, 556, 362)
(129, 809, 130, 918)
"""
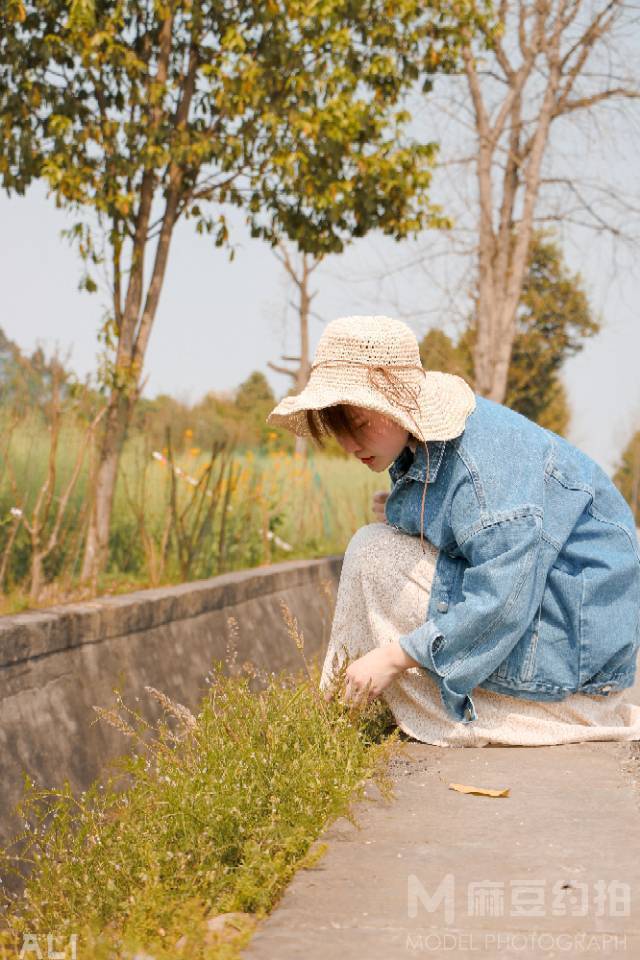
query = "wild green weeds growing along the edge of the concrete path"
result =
(0, 615, 398, 960)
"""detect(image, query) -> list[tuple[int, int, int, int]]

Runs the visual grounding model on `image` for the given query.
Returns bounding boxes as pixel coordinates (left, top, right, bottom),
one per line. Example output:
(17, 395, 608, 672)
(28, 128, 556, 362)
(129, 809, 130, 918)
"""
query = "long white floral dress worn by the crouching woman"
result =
(320, 523, 640, 747)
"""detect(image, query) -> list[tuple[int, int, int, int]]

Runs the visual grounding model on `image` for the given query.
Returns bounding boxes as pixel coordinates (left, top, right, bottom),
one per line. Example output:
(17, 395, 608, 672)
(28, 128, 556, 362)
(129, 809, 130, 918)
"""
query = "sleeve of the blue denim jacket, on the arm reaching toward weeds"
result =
(399, 507, 546, 723)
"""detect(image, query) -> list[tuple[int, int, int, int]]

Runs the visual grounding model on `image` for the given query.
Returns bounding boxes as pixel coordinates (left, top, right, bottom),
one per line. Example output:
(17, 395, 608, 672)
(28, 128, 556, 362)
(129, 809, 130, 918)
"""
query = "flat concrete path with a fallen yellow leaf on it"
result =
(242, 741, 640, 960)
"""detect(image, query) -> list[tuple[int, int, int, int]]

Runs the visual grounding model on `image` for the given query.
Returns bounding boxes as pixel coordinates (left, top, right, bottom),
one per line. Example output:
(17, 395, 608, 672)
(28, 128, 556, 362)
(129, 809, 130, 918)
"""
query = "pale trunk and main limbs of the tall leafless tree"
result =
(462, 0, 576, 403)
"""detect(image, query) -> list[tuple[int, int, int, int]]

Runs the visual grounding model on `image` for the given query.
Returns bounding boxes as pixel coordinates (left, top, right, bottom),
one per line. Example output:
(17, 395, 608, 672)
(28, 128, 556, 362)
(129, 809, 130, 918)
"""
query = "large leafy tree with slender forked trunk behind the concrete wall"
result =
(0, 0, 488, 579)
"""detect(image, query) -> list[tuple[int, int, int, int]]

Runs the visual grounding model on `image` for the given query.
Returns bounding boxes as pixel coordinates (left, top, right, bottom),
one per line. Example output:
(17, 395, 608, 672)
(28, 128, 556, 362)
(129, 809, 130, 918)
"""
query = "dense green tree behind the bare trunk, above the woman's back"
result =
(420, 233, 600, 434)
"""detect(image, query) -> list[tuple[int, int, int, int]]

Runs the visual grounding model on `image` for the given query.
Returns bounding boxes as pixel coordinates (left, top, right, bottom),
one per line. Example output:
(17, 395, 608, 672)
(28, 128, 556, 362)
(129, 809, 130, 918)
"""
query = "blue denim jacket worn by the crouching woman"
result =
(385, 396, 640, 723)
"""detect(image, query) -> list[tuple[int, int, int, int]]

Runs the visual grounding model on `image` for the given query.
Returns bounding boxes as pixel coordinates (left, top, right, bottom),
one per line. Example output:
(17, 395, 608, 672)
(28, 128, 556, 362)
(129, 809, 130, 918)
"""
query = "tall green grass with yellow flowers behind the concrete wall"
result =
(0, 412, 380, 613)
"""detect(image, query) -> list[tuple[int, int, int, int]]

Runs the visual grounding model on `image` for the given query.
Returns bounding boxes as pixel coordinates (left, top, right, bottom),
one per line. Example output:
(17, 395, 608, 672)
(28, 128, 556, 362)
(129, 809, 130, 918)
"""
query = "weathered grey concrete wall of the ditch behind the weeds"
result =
(0, 556, 342, 860)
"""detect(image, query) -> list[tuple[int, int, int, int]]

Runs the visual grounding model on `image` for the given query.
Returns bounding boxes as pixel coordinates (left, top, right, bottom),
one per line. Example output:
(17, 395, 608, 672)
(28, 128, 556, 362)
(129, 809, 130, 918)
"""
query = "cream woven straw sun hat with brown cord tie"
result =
(267, 316, 476, 442)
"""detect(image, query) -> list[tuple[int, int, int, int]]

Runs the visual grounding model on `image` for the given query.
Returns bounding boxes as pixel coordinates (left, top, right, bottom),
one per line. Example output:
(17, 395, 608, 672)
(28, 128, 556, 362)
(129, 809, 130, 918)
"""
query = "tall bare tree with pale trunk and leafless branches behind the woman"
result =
(463, 0, 639, 401)
